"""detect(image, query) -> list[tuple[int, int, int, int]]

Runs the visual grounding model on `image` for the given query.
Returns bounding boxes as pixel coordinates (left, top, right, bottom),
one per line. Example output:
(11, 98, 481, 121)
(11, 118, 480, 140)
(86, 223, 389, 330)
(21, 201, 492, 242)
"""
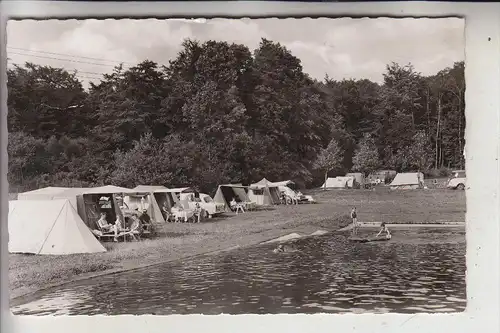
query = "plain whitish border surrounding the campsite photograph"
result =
(0, 1, 500, 333)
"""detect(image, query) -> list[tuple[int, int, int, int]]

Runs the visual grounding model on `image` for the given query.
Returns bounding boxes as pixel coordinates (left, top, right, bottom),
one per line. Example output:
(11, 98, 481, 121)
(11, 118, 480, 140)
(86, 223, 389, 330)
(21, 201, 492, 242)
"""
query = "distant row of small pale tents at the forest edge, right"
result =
(321, 171, 425, 190)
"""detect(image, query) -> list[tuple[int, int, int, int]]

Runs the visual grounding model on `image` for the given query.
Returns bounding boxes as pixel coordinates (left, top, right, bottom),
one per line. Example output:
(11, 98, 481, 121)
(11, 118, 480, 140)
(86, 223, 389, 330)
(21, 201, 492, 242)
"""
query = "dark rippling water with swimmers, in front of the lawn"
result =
(12, 227, 466, 315)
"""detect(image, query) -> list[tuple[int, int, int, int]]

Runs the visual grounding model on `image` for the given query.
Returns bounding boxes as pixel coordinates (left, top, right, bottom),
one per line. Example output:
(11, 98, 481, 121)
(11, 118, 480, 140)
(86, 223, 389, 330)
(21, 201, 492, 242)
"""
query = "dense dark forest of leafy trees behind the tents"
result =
(8, 39, 465, 193)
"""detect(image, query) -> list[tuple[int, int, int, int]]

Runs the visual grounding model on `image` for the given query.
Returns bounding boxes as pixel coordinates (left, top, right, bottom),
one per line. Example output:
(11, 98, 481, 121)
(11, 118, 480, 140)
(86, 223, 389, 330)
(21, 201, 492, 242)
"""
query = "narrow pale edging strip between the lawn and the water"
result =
(9, 222, 465, 308)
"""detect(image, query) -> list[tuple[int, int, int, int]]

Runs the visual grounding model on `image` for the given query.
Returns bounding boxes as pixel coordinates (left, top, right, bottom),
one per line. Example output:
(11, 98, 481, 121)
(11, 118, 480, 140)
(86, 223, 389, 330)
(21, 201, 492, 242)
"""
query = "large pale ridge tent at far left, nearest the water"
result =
(8, 199, 106, 255)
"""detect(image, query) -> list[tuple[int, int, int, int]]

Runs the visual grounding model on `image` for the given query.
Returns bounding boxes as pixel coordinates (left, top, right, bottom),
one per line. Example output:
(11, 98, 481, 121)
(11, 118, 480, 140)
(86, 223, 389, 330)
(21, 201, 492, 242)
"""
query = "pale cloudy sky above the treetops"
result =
(7, 18, 465, 85)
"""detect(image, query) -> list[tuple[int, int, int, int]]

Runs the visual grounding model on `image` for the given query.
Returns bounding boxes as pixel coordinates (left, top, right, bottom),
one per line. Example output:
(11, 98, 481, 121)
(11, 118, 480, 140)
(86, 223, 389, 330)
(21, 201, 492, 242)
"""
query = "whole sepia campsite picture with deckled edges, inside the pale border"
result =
(6, 17, 468, 316)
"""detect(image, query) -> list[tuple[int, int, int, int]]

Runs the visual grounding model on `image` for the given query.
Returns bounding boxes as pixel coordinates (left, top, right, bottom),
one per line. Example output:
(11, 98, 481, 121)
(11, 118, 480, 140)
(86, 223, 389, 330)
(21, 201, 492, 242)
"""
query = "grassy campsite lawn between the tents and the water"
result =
(9, 189, 466, 298)
